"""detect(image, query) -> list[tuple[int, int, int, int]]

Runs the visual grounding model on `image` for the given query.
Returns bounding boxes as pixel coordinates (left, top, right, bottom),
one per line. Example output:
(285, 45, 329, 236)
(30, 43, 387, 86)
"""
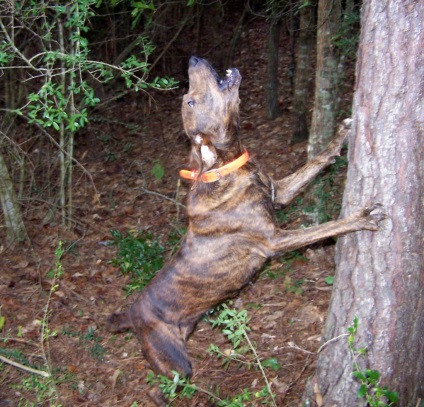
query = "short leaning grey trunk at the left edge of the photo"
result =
(0, 152, 28, 242)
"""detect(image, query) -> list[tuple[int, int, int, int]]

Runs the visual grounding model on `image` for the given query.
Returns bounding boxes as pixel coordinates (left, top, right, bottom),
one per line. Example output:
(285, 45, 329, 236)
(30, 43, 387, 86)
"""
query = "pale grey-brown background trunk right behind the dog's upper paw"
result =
(308, 0, 341, 159)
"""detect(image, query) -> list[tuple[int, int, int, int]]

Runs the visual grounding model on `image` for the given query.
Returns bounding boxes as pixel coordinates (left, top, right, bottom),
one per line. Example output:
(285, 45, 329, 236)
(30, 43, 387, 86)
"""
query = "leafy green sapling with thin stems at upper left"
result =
(0, 0, 174, 236)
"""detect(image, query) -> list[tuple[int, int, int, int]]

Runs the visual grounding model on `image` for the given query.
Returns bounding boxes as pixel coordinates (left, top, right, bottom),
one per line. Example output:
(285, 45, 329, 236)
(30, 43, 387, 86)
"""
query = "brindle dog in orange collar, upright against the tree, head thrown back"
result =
(108, 57, 385, 406)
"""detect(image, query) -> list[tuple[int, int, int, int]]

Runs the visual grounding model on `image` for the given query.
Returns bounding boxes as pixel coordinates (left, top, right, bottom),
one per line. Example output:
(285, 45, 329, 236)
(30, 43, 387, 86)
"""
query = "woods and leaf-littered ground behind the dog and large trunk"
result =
(0, 0, 366, 406)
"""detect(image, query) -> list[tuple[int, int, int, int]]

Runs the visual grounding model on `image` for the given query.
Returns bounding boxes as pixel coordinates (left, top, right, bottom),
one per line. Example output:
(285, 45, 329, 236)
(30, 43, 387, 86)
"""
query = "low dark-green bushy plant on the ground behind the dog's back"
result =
(110, 230, 165, 294)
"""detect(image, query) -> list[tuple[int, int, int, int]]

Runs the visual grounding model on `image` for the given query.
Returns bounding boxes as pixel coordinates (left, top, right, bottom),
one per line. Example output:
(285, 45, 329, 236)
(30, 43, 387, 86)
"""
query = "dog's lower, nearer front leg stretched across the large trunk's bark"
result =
(269, 204, 386, 255)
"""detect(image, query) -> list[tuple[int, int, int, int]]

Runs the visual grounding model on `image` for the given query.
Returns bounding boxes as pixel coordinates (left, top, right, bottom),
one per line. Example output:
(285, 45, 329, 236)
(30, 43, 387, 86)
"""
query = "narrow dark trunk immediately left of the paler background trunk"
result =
(293, 5, 314, 143)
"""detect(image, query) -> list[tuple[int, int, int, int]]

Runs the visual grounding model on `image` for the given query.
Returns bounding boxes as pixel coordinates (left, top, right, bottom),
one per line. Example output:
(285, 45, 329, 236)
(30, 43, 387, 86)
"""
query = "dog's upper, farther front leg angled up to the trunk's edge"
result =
(274, 119, 352, 205)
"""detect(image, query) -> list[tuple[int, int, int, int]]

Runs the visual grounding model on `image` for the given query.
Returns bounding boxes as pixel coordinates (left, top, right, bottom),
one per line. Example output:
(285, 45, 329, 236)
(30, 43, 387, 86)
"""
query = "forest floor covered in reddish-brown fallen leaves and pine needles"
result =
(0, 19, 352, 406)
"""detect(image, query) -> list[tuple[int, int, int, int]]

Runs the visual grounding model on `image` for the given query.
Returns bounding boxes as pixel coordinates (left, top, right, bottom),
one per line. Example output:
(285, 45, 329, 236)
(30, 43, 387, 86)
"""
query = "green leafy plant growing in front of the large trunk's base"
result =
(347, 317, 398, 407)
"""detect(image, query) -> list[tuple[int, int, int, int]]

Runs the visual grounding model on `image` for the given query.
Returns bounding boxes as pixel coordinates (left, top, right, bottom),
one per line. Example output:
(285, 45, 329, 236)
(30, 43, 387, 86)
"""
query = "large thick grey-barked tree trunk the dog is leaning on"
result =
(304, 0, 424, 407)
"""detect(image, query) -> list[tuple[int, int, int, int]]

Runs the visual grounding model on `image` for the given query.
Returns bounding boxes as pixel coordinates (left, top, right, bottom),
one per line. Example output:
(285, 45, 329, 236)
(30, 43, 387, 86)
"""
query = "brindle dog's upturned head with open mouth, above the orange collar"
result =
(182, 57, 241, 169)
